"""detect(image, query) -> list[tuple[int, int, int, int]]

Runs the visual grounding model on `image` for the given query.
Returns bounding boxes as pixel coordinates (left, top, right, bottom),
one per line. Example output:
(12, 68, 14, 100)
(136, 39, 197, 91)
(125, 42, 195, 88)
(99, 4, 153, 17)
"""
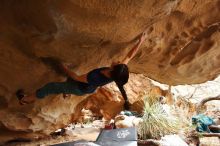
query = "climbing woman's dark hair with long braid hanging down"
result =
(111, 64, 129, 101)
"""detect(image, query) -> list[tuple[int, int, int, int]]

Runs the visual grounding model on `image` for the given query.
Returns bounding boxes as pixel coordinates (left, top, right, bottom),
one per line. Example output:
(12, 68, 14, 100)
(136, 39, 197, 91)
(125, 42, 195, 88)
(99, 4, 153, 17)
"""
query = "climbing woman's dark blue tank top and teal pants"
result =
(36, 67, 113, 98)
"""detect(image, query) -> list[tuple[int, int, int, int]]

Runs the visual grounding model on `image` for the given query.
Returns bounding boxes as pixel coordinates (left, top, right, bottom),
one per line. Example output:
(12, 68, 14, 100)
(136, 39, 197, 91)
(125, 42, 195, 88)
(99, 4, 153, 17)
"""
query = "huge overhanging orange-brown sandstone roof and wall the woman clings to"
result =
(0, 0, 220, 143)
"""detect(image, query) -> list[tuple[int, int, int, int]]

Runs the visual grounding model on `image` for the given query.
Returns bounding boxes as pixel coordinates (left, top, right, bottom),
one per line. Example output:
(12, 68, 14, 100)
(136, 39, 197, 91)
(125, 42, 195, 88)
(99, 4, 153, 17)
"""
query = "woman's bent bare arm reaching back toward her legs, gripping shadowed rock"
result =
(61, 64, 87, 83)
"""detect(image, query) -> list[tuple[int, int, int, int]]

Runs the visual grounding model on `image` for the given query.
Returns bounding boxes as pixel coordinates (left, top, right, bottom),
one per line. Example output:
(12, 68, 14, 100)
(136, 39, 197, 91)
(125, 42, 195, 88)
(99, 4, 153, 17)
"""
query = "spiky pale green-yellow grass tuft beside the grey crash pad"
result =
(138, 95, 179, 140)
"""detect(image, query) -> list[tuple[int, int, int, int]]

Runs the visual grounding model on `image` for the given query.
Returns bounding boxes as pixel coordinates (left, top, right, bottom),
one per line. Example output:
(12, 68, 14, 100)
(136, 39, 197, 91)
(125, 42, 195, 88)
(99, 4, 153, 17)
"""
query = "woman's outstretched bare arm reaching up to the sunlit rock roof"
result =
(121, 32, 146, 64)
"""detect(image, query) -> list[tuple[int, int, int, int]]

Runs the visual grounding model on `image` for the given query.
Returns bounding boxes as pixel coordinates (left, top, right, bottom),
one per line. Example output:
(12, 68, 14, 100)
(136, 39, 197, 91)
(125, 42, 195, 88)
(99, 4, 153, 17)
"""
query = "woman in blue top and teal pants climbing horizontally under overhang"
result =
(16, 33, 146, 110)
